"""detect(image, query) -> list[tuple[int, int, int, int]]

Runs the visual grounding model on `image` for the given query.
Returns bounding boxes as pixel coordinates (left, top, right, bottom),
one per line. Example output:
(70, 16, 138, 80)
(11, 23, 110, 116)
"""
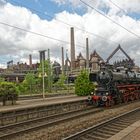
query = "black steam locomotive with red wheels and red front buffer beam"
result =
(88, 67, 140, 107)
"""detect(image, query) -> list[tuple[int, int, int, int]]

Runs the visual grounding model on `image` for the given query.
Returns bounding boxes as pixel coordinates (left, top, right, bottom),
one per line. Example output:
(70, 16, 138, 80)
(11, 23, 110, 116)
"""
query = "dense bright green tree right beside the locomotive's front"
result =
(75, 71, 94, 96)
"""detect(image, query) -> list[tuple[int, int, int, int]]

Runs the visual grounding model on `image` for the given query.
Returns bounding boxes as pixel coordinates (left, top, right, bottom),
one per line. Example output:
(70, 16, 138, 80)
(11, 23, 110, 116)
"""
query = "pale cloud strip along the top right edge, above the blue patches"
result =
(52, 0, 140, 14)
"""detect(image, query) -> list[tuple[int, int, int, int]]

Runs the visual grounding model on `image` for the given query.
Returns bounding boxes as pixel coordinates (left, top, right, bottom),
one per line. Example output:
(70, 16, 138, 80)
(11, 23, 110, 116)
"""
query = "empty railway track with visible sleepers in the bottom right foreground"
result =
(63, 108, 140, 140)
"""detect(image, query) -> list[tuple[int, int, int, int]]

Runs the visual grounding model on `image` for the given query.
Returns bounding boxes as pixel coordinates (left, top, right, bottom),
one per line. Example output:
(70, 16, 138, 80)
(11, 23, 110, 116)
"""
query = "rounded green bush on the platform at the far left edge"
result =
(0, 82, 18, 105)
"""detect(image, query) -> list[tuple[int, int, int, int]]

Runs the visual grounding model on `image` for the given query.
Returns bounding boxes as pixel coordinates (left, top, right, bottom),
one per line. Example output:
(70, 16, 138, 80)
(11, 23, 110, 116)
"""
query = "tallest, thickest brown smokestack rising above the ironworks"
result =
(70, 27, 75, 70)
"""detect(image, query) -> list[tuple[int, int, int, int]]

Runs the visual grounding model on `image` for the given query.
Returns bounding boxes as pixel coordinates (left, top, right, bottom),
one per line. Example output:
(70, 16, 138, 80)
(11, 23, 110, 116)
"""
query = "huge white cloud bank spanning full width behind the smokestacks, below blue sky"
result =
(0, 1, 140, 68)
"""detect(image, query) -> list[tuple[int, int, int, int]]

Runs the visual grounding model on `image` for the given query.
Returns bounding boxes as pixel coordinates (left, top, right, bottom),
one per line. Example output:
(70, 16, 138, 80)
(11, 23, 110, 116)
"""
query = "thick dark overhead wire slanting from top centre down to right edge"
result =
(80, 0, 140, 38)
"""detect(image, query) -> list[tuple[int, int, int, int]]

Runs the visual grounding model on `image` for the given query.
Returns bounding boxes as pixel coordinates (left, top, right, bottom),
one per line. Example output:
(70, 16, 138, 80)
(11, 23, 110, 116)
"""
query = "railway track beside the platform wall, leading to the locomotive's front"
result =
(0, 107, 103, 140)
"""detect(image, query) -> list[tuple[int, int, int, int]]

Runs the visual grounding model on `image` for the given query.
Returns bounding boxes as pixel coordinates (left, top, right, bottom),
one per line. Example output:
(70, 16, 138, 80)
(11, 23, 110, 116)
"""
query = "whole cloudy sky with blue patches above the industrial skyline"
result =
(0, 0, 140, 67)
